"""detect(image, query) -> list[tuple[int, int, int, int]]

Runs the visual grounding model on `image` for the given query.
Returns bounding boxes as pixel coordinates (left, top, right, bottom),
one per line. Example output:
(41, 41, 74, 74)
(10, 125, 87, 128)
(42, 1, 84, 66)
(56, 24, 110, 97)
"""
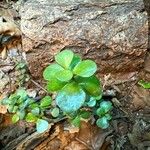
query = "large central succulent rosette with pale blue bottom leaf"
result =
(43, 50, 102, 113)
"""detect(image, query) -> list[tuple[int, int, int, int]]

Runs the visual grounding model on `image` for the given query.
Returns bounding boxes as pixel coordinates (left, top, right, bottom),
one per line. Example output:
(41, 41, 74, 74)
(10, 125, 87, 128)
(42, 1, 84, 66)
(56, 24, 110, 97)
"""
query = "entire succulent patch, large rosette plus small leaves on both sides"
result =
(1, 50, 113, 133)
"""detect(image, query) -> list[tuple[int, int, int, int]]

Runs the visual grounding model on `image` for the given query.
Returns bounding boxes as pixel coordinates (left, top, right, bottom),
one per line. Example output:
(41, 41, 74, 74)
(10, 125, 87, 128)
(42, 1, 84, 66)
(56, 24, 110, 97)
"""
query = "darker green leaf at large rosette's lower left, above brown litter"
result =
(46, 78, 66, 92)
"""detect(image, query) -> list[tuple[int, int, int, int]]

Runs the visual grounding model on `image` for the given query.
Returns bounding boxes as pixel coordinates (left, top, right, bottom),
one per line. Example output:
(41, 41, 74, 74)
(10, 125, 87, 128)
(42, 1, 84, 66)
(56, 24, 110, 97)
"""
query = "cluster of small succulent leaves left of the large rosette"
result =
(1, 88, 54, 133)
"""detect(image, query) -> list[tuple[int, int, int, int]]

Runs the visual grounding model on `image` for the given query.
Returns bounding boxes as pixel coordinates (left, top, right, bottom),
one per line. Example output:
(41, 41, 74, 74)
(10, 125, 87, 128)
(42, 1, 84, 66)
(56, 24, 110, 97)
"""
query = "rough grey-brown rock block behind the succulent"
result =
(20, 0, 148, 78)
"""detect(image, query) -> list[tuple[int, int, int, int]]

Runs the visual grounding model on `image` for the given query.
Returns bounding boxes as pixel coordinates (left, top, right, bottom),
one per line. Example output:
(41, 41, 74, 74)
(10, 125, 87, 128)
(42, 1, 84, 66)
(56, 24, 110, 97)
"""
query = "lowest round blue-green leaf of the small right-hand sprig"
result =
(96, 117, 109, 129)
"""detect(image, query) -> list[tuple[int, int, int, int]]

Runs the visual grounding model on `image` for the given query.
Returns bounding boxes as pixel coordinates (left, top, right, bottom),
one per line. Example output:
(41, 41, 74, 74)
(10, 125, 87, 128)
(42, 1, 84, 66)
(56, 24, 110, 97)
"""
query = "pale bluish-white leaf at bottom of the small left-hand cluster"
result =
(36, 119, 48, 133)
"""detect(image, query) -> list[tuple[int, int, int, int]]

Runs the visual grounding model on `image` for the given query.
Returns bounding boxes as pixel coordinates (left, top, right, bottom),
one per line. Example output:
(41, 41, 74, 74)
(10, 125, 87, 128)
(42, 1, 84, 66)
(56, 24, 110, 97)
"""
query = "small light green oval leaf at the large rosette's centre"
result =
(56, 70, 73, 82)
